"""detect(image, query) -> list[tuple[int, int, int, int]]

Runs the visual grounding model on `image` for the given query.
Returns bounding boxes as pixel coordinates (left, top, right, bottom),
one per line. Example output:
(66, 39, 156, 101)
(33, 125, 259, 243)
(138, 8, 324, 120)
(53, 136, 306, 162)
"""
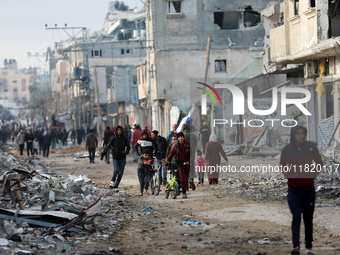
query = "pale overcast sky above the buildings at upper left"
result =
(0, 0, 143, 69)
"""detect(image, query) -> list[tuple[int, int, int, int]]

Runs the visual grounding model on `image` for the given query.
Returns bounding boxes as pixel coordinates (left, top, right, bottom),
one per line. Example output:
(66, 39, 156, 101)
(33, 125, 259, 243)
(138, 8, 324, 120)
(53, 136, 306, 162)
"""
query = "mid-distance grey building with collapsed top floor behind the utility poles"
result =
(49, 1, 146, 130)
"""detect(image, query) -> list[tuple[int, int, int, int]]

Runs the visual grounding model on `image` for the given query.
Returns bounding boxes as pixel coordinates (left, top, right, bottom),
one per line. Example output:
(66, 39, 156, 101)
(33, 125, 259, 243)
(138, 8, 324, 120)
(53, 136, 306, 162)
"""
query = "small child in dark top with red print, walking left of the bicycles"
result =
(137, 151, 152, 196)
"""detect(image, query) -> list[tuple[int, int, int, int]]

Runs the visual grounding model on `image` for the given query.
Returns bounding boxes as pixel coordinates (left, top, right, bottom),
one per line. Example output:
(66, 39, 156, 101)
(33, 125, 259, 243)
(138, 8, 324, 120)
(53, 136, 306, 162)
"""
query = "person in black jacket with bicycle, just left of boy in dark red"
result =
(151, 130, 168, 185)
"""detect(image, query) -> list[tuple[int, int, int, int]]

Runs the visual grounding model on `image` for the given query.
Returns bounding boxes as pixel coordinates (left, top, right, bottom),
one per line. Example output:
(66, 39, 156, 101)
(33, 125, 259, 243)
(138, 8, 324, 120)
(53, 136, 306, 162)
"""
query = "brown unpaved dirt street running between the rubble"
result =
(21, 147, 340, 255)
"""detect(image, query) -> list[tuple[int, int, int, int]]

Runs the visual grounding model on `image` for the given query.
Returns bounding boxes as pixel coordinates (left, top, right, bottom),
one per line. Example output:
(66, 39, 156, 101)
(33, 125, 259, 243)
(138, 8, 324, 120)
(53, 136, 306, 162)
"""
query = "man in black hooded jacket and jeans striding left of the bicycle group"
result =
(100, 126, 130, 192)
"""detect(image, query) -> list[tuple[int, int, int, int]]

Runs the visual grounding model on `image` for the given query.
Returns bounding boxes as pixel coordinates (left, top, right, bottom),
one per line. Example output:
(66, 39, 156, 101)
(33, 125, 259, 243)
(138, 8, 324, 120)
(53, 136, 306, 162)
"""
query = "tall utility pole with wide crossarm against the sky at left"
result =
(45, 24, 91, 127)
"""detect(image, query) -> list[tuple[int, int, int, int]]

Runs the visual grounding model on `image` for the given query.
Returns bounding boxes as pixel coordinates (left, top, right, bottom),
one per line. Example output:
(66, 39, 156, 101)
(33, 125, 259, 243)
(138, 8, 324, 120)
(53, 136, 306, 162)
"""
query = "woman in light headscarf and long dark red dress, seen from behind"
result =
(205, 134, 228, 184)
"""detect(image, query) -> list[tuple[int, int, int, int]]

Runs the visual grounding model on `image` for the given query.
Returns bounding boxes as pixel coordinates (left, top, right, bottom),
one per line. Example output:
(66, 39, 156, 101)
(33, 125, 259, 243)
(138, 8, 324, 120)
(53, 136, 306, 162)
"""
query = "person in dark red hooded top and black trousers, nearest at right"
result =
(280, 125, 323, 255)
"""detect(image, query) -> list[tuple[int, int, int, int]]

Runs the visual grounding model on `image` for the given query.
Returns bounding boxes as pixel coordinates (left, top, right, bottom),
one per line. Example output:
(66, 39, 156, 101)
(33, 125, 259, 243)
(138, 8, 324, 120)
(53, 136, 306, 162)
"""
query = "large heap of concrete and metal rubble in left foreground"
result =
(0, 144, 150, 254)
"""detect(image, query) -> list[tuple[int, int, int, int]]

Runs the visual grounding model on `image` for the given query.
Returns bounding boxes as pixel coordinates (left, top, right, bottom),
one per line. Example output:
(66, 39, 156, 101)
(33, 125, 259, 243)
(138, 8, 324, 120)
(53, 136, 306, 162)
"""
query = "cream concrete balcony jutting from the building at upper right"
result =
(270, 0, 340, 65)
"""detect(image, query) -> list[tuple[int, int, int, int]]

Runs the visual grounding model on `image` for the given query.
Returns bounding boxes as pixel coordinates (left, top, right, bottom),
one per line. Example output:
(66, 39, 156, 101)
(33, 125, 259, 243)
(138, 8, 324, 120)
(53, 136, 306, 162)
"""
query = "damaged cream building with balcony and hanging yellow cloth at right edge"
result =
(262, 0, 340, 148)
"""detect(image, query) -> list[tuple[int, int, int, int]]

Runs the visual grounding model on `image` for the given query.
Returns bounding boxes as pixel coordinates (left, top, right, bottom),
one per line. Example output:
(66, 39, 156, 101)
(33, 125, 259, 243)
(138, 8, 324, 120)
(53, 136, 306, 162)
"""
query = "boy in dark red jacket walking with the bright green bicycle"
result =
(166, 132, 190, 198)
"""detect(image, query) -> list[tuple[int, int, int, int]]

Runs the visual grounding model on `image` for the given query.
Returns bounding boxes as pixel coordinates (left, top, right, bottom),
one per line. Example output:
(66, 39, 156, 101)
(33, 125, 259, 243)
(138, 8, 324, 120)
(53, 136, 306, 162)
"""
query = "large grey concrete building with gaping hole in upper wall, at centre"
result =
(139, 0, 269, 134)
